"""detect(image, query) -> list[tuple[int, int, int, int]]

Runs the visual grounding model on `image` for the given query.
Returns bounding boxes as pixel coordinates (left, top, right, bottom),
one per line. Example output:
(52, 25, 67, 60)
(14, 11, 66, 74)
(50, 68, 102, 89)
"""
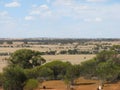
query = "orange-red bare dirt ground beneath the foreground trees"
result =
(36, 78, 120, 90)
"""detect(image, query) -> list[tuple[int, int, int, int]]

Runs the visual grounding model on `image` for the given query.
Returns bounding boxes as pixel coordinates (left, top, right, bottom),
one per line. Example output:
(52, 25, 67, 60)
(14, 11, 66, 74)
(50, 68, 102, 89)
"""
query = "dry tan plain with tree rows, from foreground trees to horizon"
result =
(0, 38, 120, 71)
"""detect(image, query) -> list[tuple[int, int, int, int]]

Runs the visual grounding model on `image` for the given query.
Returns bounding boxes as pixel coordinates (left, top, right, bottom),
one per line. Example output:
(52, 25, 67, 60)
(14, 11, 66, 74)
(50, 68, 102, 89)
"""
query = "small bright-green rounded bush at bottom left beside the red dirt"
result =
(24, 79, 39, 90)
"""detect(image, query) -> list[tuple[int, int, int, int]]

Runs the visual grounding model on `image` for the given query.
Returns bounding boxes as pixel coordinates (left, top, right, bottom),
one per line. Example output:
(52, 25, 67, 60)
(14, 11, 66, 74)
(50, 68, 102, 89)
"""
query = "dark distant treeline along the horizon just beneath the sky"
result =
(0, 38, 120, 44)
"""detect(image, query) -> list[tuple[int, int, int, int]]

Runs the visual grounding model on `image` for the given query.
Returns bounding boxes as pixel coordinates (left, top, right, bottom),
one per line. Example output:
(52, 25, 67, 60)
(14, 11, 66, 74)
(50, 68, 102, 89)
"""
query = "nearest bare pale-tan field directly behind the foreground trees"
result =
(0, 54, 95, 72)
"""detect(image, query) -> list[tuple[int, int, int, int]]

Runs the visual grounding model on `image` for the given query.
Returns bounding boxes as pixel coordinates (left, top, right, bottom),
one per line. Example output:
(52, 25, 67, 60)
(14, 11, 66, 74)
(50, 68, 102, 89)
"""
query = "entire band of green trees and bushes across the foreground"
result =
(0, 47, 120, 90)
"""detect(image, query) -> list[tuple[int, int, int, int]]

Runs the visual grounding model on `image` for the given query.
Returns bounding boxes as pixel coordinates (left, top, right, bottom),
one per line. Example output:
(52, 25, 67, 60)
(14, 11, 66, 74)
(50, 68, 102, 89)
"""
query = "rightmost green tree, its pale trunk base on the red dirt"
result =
(96, 50, 120, 89)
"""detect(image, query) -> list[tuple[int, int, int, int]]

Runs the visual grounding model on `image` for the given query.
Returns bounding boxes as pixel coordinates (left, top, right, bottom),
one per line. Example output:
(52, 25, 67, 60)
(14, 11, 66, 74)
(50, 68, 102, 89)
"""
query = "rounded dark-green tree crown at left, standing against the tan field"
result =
(10, 49, 46, 68)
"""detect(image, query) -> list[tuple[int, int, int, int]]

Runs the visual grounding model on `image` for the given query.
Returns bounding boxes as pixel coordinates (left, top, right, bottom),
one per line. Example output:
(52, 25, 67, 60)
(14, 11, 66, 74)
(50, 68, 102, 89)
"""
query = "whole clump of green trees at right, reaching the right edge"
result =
(81, 50, 120, 82)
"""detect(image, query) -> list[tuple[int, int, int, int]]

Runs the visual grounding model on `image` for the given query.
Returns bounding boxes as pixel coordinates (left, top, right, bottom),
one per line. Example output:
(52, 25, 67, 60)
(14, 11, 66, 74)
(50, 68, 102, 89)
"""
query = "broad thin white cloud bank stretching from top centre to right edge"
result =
(53, 0, 120, 22)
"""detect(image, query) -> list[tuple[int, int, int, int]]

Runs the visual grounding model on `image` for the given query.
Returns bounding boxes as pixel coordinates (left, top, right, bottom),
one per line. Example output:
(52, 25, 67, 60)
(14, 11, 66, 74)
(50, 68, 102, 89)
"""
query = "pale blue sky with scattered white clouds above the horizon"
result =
(0, 0, 120, 38)
